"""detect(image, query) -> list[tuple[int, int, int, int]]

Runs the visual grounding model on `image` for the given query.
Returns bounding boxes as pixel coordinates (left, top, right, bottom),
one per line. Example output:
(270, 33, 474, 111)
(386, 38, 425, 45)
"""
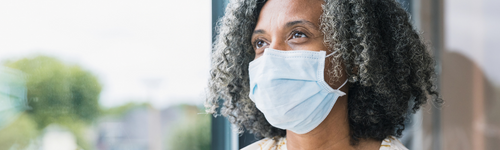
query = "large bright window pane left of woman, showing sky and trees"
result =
(0, 0, 212, 150)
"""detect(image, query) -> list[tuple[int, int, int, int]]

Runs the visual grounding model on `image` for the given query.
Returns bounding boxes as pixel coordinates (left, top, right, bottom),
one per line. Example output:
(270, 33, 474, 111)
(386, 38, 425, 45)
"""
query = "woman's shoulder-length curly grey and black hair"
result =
(205, 0, 443, 144)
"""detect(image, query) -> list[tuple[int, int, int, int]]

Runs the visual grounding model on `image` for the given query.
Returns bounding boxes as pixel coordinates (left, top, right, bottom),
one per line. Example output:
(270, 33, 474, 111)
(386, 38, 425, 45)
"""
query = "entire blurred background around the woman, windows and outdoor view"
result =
(0, 0, 500, 150)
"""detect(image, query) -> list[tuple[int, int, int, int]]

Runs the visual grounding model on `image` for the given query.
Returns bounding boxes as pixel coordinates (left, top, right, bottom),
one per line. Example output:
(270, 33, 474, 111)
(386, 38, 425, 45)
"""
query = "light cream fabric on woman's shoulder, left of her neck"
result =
(241, 138, 286, 150)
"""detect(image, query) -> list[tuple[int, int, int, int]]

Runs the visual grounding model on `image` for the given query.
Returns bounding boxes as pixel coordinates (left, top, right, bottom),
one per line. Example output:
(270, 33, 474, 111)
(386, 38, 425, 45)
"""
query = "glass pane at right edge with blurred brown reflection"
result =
(441, 0, 500, 150)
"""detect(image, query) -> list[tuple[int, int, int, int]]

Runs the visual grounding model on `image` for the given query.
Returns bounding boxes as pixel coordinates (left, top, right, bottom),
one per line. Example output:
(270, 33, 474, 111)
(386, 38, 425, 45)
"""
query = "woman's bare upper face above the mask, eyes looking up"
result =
(252, 0, 327, 59)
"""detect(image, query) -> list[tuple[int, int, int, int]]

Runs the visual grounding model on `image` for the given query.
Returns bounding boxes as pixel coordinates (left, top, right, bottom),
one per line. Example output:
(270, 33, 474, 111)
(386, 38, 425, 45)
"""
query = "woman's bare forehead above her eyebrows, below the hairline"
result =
(257, 0, 323, 28)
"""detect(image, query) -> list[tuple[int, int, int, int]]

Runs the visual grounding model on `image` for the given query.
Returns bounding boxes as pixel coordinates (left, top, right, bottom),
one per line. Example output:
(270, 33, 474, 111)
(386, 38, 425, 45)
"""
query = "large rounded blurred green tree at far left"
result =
(6, 56, 101, 129)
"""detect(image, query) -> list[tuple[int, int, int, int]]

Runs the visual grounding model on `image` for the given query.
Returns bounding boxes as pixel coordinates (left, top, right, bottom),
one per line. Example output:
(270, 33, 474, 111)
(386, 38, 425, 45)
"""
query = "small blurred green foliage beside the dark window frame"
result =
(167, 106, 211, 150)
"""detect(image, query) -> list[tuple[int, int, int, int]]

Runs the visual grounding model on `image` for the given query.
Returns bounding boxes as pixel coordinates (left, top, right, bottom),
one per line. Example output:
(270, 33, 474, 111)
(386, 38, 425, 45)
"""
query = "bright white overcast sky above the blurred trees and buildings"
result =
(0, 0, 211, 108)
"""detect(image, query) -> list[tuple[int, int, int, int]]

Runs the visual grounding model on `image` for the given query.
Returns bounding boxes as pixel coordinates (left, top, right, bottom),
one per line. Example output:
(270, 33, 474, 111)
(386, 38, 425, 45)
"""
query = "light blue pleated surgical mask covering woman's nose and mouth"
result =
(249, 48, 347, 134)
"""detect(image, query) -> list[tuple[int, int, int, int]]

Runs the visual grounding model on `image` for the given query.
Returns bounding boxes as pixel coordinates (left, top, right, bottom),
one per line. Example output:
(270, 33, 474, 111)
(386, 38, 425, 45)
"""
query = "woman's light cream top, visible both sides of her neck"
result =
(241, 136, 408, 150)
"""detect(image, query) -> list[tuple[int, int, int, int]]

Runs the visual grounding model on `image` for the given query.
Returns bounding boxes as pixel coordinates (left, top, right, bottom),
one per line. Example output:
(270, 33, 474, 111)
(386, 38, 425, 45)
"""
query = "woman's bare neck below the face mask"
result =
(286, 95, 381, 150)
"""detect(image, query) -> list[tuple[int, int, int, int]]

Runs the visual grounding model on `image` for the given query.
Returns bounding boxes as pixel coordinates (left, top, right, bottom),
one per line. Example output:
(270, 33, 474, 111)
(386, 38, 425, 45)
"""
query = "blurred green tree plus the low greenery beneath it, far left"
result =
(0, 56, 101, 149)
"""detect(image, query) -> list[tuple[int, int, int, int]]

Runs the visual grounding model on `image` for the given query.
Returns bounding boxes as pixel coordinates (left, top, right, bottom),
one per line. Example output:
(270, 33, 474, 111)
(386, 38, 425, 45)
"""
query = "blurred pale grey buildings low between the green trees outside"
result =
(93, 106, 192, 150)
